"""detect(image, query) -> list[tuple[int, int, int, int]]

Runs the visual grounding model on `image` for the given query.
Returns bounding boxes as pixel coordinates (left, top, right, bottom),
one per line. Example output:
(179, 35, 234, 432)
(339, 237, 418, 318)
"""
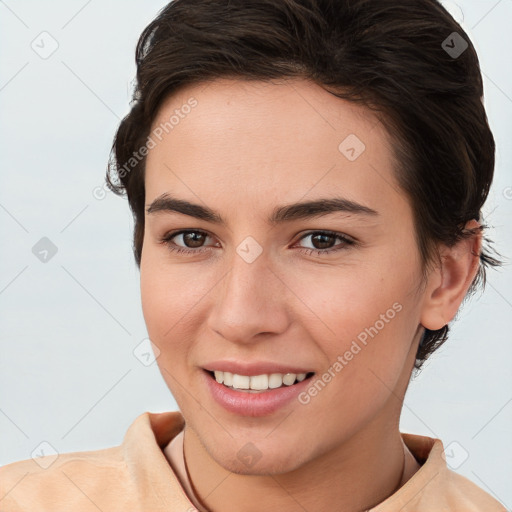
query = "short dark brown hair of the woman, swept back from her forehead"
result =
(107, 0, 501, 369)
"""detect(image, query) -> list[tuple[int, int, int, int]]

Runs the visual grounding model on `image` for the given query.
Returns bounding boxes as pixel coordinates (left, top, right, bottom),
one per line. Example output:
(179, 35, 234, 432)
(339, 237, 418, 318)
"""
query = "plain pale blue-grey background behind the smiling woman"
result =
(0, 0, 512, 508)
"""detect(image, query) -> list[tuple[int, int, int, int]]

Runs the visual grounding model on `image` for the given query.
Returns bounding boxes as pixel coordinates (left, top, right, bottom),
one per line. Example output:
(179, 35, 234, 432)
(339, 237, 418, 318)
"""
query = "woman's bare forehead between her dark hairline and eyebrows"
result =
(146, 79, 405, 219)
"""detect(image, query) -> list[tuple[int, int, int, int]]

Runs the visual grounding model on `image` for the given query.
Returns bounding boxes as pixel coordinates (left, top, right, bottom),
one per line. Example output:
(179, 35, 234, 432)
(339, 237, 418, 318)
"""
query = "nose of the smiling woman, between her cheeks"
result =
(208, 248, 291, 344)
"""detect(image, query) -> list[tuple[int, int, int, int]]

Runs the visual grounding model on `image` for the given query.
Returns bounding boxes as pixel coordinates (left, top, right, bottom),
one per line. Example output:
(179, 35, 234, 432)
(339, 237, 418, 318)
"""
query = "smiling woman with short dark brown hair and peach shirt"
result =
(0, 0, 505, 512)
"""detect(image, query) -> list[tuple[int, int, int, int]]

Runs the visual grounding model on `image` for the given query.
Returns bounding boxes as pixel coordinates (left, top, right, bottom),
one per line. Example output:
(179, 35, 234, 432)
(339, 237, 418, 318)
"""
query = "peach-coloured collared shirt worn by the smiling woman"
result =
(0, 411, 506, 512)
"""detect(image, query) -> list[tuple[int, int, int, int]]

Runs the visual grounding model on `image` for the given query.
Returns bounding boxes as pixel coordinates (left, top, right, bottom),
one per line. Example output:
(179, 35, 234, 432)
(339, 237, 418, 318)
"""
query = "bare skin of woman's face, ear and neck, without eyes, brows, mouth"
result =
(140, 79, 481, 512)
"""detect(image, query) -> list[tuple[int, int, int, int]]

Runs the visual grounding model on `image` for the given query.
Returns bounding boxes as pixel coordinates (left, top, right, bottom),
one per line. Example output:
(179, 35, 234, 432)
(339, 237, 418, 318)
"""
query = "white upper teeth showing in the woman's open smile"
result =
(204, 370, 315, 393)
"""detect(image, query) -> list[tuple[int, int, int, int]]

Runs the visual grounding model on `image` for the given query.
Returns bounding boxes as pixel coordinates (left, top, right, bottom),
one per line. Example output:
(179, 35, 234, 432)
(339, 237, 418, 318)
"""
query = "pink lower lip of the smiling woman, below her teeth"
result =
(203, 370, 311, 417)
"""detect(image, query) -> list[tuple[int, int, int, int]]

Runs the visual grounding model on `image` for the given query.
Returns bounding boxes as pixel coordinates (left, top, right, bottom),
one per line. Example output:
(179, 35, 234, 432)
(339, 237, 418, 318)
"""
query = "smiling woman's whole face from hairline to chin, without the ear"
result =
(140, 80, 428, 474)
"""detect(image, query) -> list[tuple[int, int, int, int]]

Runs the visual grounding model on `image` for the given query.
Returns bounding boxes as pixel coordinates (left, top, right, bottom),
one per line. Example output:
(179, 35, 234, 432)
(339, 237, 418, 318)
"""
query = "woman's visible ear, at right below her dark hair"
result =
(421, 219, 482, 331)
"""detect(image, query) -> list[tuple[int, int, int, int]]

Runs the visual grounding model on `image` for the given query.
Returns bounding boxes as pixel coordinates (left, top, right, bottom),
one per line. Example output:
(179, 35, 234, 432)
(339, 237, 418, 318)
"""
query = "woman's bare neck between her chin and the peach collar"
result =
(184, 406, 419, 512)
